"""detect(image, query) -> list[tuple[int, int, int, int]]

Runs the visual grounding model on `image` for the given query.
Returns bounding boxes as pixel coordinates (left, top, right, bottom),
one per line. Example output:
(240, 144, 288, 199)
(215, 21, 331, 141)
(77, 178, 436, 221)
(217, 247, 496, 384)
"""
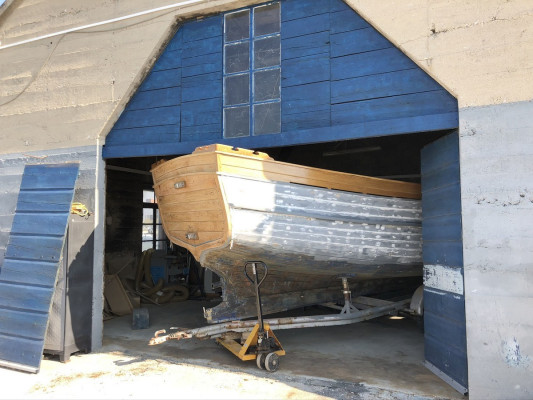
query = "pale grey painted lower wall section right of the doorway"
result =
(460, 101, 533, 399)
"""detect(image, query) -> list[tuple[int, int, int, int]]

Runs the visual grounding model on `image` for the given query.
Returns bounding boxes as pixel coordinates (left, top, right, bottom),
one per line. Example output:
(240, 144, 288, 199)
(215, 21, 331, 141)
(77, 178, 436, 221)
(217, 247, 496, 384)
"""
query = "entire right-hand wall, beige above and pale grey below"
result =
(340, 0, 533, 399)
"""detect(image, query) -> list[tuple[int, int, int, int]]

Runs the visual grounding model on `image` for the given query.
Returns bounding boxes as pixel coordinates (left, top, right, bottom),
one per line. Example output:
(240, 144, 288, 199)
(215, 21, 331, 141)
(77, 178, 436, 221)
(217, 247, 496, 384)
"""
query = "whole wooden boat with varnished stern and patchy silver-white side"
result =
(152, 145, 422, 323)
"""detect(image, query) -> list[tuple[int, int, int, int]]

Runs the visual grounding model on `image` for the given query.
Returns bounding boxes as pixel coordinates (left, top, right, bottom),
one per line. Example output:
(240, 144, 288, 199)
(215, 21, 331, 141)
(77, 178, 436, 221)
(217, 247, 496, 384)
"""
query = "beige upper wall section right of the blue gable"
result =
(346, 0, 533, 107)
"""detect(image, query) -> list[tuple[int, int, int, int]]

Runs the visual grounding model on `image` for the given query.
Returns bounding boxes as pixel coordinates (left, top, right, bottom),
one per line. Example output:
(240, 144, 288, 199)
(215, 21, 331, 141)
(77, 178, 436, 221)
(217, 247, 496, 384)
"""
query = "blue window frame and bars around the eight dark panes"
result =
(222, 1, 281, 139)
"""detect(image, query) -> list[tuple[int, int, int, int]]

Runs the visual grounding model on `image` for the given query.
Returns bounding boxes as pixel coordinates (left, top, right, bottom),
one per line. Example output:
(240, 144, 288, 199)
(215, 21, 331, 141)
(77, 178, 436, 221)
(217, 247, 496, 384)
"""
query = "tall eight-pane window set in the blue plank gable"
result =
(224, 2, 281, 138)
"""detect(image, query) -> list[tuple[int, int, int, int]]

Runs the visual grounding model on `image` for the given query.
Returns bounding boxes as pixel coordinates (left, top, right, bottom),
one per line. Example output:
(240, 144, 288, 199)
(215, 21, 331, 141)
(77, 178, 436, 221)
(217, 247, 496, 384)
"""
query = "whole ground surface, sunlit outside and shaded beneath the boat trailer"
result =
(0, 301, 464, 400)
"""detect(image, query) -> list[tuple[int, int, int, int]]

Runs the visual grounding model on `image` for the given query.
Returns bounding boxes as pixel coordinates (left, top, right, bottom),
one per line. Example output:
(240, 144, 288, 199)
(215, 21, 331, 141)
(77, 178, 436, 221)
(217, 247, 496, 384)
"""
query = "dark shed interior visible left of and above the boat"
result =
(104, 131, 447, 325)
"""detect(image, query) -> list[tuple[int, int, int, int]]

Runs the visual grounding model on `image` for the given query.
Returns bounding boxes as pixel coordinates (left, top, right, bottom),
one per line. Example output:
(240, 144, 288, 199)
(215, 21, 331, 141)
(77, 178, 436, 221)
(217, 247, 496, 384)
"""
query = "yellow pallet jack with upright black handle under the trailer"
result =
(217, 261, 285, 372)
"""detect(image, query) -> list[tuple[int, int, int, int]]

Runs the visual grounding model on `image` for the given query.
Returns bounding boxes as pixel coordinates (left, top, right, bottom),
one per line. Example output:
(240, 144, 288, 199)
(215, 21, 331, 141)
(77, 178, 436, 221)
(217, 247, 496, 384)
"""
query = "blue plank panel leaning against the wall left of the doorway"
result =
(0, 163, 79, 372)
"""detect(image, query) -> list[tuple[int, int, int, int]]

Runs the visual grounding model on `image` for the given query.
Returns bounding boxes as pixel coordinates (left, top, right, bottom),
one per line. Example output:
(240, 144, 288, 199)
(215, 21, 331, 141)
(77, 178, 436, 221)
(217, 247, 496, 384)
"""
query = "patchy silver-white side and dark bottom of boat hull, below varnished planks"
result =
(200, 174, 422, 322)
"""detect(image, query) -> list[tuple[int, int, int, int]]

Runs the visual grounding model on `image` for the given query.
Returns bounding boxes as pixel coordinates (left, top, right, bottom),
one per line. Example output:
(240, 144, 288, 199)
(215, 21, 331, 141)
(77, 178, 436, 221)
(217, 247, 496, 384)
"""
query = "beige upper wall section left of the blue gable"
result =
(0, 0, 266, 154)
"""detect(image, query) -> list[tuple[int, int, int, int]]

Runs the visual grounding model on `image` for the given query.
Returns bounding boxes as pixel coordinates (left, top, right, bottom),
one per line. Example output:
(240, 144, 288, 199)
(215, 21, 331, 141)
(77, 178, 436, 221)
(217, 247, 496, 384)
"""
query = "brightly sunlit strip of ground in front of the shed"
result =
(0, 344, 448, 400)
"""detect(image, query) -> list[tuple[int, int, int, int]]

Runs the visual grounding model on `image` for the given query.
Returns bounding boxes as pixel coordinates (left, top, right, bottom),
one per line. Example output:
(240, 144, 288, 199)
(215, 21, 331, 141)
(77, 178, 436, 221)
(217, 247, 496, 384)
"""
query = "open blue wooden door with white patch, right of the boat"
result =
(421, 133, 468, 388)
